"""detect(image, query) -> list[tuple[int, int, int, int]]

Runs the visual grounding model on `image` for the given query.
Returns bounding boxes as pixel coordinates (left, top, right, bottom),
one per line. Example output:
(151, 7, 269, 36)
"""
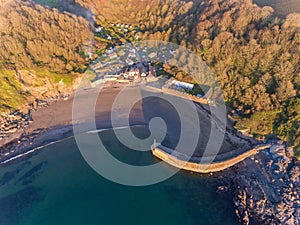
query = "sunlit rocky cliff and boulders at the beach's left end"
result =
(0, 70, 82, 141)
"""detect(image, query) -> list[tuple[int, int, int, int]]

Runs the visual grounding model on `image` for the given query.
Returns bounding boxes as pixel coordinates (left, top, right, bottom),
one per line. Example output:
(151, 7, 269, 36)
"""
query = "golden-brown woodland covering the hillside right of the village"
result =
(92, 0, 300, 156)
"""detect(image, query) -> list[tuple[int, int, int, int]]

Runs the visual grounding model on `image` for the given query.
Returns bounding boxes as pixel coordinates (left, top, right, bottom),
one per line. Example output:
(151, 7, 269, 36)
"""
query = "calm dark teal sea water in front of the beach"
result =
(0, 129, 239, 225)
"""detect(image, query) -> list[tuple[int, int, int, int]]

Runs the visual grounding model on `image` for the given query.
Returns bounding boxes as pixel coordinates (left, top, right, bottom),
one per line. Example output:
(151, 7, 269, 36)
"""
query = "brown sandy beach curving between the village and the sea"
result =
(0, 82, 258, 162)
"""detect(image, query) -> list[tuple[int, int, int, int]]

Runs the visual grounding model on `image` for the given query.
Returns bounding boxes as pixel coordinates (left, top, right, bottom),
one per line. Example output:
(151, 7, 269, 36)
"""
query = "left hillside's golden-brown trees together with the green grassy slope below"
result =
(0, 0, 93, 111)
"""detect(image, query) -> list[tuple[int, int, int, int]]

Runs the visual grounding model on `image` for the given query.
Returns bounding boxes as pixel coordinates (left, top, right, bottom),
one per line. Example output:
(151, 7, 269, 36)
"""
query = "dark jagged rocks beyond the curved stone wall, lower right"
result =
(222, 143, 300, 225)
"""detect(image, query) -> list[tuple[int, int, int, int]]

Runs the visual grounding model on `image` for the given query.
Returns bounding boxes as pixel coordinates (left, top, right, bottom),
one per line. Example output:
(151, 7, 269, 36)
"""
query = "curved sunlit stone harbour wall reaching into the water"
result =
(152, 144, 271, 173)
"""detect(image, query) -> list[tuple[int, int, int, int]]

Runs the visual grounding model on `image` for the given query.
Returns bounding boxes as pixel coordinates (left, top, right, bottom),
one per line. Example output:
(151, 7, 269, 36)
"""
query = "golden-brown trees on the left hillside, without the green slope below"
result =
(0, 0, 92, 72)
